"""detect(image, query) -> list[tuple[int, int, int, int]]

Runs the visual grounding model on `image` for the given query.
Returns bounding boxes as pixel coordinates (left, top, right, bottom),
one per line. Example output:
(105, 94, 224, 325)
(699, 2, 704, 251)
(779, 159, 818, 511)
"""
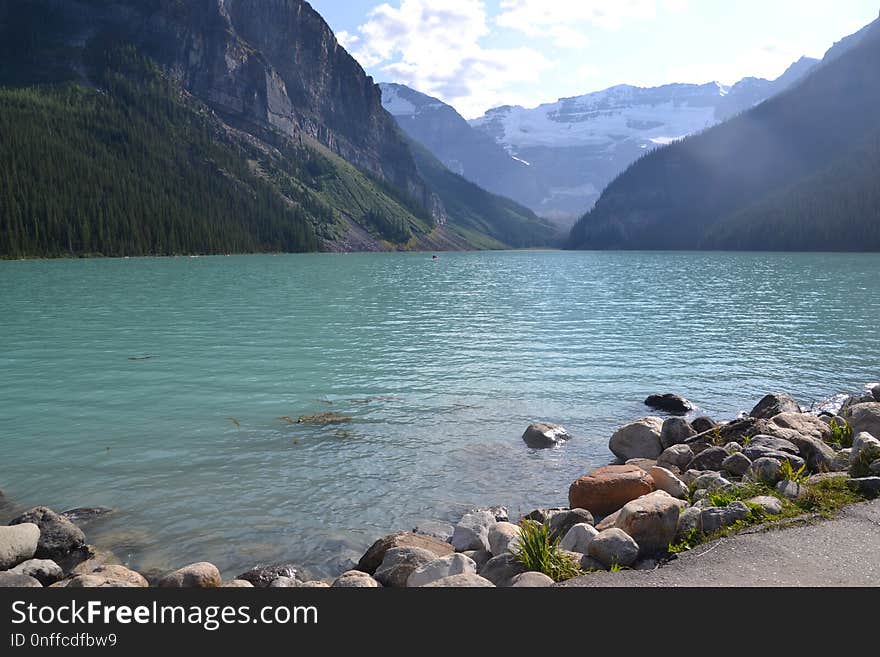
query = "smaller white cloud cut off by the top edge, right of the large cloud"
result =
(495, 0, 688, 49)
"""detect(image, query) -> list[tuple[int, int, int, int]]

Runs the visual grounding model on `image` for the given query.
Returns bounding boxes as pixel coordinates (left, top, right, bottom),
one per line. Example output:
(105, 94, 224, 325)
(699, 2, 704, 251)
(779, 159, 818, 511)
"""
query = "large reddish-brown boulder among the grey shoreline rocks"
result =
(568, 465, 654, 516)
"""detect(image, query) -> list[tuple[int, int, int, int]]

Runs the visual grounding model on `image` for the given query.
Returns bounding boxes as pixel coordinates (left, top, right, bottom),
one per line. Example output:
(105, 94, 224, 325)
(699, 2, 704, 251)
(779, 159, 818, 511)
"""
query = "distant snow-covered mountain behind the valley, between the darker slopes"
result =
(460, 58, 817, 225)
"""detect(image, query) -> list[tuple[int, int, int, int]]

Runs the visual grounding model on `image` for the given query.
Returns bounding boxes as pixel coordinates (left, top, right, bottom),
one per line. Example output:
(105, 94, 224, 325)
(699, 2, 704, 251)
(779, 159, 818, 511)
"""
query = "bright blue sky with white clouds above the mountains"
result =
(310, 0, 880, 118)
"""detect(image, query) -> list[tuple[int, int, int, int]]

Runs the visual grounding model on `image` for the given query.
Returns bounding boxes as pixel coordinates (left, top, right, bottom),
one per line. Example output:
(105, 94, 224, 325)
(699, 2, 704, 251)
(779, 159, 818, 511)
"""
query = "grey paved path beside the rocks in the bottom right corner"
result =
(561, 500, 880, 587)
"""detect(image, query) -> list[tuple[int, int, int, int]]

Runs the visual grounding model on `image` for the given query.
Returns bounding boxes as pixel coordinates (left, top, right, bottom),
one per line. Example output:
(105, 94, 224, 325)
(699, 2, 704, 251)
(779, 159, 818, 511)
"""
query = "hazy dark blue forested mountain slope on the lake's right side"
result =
(570, 16, 880, 250)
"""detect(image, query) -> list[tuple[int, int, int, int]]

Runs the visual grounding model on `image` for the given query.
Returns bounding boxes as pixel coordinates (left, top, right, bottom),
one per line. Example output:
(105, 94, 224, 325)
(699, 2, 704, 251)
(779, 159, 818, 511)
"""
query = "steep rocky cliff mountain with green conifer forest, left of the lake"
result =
(0, 0, 546, 257)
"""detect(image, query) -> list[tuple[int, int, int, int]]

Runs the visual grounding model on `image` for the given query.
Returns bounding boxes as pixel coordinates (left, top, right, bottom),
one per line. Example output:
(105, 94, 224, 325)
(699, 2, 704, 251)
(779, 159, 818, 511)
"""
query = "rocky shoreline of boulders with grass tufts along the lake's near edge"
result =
(0, 384, 880, 588)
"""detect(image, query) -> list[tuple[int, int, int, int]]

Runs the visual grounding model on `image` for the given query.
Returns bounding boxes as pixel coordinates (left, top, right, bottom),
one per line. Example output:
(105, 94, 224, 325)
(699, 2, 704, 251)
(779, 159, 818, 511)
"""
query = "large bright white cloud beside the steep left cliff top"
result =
(337, 0, 552, 117)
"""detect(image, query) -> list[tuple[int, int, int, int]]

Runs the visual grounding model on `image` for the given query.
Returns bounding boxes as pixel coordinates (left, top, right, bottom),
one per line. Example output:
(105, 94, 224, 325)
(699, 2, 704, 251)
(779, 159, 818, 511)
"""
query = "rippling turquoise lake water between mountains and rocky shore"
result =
(0, 252, 880, 576)
